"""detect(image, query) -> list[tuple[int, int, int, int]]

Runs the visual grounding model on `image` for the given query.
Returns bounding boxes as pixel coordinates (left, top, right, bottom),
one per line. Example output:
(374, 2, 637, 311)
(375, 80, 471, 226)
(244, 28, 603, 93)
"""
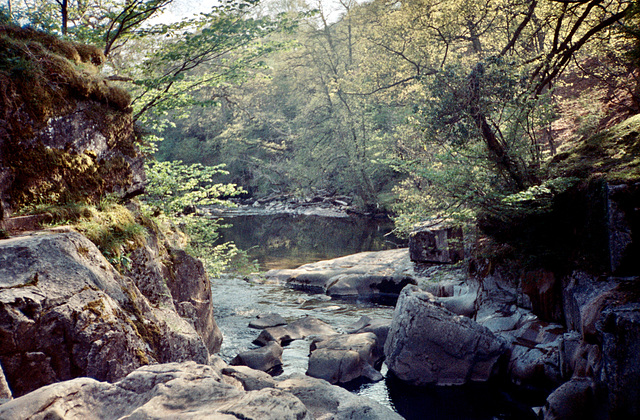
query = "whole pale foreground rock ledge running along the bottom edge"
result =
(0, 361, 401, 420)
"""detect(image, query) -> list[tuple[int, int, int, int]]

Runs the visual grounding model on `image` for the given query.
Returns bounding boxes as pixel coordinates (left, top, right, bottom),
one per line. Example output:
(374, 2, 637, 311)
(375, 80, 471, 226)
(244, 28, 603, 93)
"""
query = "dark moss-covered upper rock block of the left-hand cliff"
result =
(0, 26, 144, 218)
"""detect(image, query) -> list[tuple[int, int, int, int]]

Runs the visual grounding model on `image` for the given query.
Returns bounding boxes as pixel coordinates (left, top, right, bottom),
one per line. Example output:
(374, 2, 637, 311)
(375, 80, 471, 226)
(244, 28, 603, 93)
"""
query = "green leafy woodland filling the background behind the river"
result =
(0, 0, 640, 270)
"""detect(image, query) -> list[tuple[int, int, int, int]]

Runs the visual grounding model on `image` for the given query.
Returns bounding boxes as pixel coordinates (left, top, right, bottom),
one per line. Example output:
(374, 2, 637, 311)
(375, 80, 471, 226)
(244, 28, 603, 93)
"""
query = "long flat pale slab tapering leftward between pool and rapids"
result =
(265, 248, 418, 304)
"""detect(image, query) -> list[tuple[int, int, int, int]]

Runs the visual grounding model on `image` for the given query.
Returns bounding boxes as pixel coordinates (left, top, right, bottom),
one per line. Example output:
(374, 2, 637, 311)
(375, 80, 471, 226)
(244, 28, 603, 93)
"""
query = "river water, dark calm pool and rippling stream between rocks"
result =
(211, 215, 533, 420)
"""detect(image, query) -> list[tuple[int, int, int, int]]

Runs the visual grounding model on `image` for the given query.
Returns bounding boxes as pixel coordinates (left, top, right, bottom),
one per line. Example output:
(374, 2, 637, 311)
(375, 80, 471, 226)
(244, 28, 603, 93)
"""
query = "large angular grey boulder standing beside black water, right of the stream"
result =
(384, 286, 506, 385)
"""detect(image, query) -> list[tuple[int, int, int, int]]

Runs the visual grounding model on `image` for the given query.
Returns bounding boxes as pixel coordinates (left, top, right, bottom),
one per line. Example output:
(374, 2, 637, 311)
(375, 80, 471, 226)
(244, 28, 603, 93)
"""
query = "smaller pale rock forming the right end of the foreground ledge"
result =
(277, 374, 402, 420)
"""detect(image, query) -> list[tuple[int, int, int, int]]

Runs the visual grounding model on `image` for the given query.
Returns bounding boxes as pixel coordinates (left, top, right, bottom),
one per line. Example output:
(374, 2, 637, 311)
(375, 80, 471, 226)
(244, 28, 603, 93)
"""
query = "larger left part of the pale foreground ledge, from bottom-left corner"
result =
(0, 362, 312, 420)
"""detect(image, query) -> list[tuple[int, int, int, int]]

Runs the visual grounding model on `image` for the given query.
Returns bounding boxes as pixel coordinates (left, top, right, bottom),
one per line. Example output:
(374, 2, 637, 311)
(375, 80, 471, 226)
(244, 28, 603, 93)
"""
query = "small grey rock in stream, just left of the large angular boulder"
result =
(307, 333, 383, 384)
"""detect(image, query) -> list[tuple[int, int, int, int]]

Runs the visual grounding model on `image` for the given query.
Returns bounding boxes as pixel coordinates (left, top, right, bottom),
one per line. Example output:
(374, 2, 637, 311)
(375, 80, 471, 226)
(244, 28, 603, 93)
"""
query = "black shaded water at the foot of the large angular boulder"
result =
(386, 373, 537, 420)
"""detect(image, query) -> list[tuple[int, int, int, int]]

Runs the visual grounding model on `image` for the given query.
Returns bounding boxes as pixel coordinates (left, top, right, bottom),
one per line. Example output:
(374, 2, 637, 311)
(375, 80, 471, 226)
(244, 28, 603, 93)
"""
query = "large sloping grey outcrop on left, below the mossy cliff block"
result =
(0, 231, 219, 396)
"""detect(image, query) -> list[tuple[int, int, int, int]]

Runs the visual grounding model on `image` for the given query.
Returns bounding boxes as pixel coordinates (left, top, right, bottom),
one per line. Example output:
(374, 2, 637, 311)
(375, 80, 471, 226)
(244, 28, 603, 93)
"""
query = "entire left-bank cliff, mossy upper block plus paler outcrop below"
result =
(0, 26, 222, 398)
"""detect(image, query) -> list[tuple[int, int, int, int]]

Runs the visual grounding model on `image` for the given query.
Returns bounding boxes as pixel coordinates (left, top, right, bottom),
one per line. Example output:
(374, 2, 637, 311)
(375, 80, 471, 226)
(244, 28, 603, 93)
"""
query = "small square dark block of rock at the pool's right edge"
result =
(409, 221, 464, 264)
